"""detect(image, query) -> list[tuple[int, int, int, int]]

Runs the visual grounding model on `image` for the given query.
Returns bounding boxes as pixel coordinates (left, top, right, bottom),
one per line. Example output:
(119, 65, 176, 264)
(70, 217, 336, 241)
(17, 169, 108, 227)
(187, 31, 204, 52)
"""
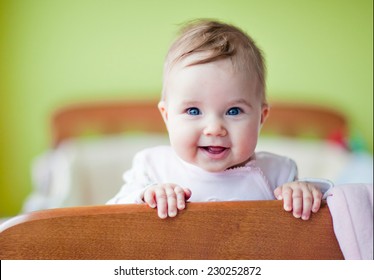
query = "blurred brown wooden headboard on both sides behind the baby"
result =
(51, 100, 347, 147)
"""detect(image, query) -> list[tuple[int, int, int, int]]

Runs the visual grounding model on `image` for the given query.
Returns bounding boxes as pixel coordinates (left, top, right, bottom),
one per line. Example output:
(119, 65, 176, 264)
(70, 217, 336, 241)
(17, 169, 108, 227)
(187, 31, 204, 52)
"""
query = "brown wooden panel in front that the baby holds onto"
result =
(0, 201, 343, 260)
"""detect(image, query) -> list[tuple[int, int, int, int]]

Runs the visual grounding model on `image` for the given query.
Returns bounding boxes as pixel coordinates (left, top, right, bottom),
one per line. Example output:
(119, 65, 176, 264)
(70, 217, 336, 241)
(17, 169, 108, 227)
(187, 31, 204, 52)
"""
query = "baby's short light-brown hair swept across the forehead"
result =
(162, 19, 266, 104)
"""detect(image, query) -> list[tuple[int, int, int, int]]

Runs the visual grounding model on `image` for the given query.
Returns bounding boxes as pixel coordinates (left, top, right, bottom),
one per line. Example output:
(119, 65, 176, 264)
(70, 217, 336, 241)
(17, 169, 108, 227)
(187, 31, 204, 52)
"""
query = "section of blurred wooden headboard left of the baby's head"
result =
(51, 100, 166, 147)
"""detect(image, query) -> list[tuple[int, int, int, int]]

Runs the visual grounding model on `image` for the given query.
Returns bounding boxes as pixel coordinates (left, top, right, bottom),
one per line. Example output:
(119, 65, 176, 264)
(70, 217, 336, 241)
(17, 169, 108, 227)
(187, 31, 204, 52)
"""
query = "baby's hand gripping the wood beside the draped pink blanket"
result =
(274, 181, 322, 220)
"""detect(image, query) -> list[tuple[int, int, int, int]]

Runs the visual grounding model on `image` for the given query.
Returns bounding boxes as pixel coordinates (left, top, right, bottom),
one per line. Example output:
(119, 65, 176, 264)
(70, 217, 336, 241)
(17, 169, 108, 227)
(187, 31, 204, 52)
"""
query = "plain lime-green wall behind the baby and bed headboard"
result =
(0, 0, 373, 216)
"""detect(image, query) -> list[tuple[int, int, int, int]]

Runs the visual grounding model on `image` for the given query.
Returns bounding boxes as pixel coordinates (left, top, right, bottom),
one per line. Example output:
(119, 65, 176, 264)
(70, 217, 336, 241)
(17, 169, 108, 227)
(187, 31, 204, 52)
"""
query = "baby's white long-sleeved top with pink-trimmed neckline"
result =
(108, 146, 318, 204)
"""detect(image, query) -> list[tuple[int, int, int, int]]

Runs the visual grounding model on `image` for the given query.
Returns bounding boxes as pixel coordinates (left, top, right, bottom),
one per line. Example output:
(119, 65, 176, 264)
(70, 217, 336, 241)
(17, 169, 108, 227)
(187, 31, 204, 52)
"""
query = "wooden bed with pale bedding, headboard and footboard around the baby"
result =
(0, 100, 373, 259)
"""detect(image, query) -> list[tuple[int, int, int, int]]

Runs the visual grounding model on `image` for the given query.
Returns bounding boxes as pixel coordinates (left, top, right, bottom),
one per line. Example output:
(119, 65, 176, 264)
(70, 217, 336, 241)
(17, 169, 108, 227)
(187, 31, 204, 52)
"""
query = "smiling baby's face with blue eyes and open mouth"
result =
(159, 59, 267, 172)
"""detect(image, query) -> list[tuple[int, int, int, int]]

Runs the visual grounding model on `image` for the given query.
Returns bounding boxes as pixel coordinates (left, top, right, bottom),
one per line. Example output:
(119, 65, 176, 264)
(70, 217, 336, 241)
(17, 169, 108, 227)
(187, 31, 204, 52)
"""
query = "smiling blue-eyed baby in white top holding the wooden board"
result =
(108, 20, 328, 220)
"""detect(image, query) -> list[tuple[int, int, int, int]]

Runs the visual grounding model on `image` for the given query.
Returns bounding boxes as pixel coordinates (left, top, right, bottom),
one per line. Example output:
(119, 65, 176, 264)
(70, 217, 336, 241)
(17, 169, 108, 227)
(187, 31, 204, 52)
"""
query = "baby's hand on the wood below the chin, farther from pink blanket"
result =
(144, 184, 191, 219)
